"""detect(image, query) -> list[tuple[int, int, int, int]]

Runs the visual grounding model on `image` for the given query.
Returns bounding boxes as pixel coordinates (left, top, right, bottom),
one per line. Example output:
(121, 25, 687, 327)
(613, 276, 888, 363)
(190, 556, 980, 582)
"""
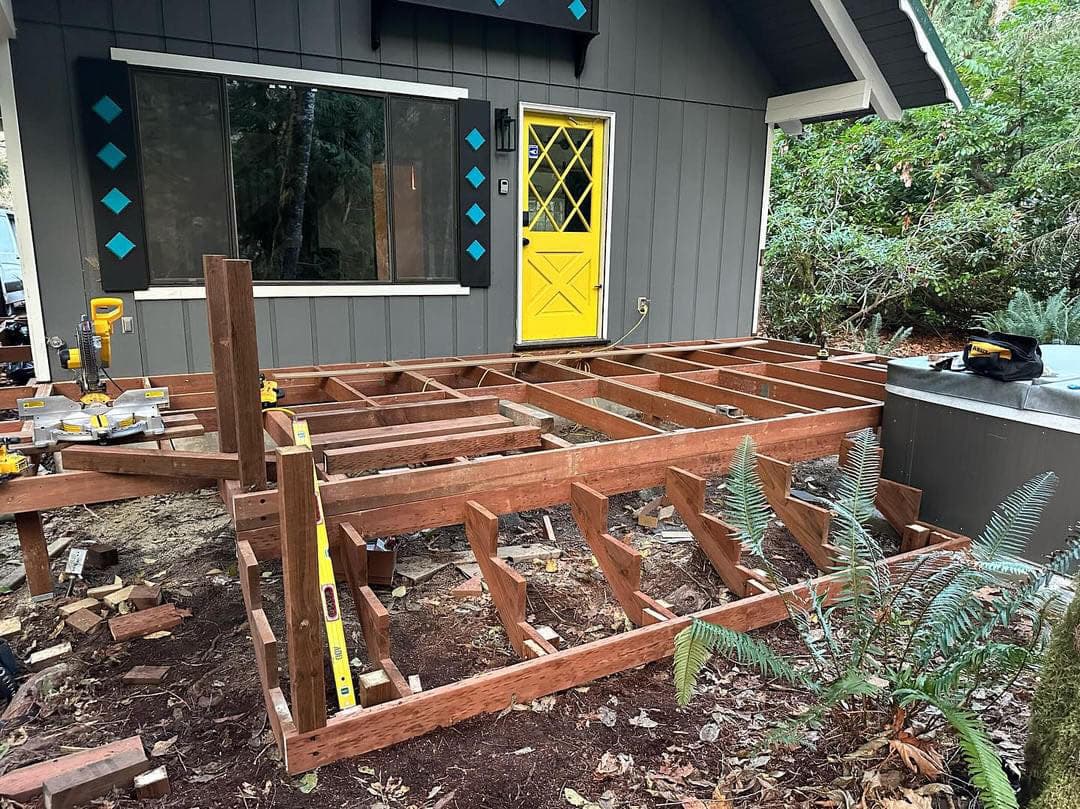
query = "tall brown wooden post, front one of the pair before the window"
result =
(225, 259, 265, 489)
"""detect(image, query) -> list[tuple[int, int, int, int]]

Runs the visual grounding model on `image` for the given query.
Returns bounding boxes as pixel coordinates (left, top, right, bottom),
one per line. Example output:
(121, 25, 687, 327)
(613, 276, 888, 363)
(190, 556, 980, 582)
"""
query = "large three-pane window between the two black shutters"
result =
(136, 71, 457, 284)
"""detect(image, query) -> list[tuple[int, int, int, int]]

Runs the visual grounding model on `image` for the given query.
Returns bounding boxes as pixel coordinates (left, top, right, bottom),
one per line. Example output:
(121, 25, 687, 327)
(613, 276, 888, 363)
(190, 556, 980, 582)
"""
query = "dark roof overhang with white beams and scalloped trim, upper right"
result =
(724, 0, 970, 132)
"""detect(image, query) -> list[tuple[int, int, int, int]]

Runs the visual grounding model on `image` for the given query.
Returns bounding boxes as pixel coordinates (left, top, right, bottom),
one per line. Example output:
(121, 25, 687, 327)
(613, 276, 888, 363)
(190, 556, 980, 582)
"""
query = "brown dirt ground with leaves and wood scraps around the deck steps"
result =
(0, 459, 1031, 809)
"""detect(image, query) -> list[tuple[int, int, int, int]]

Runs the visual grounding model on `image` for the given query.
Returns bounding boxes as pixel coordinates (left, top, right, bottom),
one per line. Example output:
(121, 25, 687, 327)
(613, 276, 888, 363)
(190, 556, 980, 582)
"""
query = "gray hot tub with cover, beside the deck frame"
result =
(881, 346, 1080, 559)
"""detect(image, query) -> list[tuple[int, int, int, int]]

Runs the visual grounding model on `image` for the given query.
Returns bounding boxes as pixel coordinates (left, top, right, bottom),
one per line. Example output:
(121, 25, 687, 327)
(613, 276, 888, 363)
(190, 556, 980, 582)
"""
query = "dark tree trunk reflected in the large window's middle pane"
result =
(271, 87, 315, 281)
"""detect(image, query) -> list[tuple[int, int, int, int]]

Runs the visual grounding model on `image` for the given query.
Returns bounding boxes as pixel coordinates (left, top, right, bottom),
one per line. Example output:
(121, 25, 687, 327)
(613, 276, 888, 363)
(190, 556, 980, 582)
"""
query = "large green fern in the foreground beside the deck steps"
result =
(675, 430, 1080, 809)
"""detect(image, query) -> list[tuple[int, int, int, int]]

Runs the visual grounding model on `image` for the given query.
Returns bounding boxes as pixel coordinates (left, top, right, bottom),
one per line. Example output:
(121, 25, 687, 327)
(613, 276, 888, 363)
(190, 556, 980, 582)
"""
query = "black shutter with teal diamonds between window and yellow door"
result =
(457, 98, 491, 286)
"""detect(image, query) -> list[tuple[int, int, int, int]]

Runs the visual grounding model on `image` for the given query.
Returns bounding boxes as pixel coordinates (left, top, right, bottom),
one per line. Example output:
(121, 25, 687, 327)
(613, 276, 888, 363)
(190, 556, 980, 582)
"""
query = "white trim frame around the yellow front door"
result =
(514, 102, 615, 345)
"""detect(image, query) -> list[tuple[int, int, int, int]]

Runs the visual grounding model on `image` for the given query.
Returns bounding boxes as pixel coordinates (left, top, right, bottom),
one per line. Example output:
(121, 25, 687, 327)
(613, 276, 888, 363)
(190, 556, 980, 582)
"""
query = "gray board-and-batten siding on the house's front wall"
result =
(12, 0, 772, 378)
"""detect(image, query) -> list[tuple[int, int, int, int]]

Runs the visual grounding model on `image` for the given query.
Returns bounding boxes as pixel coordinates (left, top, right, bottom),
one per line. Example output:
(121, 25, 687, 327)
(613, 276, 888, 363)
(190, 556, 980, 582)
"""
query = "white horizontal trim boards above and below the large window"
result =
(110, 48, 471, 300)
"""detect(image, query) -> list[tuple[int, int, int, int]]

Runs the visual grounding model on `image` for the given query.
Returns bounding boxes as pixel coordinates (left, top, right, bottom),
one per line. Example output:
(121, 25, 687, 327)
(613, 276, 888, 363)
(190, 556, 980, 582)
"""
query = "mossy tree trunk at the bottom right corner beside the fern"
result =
(1024, 579, 1080, 809)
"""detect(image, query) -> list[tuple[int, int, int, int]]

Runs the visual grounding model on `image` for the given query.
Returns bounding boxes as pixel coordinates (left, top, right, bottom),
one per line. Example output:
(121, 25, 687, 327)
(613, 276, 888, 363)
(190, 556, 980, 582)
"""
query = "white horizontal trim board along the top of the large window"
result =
(110, 48, 469, 99)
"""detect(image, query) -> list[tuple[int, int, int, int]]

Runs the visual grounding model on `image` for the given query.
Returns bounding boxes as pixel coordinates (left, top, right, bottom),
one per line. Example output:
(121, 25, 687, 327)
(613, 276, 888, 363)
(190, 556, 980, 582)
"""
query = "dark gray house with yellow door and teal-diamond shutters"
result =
(0, 0, 967, 377)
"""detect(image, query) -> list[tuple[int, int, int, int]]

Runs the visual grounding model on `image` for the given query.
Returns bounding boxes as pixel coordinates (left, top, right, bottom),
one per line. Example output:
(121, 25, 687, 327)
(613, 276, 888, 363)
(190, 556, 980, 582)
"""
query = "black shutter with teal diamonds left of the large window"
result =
(77, 57, 150, 292)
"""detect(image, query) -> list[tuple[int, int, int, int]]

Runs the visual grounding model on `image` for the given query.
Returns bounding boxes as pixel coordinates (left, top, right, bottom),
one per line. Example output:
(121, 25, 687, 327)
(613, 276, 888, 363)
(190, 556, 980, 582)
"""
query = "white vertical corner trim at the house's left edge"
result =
(0, 38, 52, 382)
